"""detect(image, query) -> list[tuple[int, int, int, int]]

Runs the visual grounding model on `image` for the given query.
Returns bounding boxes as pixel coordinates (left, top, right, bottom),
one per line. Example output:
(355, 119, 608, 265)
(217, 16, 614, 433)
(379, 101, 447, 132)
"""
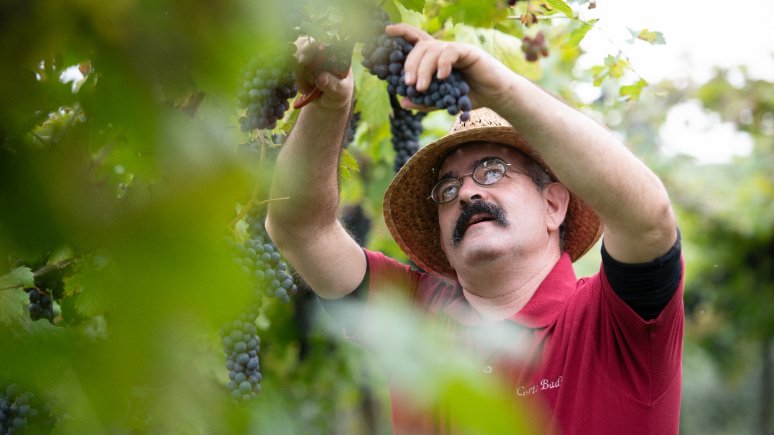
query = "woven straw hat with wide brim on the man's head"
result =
(384, 108, 602, 279)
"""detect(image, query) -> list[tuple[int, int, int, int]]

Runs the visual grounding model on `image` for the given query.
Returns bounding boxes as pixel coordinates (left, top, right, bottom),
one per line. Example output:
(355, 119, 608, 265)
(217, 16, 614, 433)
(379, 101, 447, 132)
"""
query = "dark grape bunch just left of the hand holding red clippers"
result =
(237, 46, 298, 132)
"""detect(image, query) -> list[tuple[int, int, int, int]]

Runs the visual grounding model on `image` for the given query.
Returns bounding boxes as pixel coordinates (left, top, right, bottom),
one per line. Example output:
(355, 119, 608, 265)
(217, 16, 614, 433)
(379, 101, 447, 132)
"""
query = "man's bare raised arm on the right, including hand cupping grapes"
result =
(387, 24, 677, 263)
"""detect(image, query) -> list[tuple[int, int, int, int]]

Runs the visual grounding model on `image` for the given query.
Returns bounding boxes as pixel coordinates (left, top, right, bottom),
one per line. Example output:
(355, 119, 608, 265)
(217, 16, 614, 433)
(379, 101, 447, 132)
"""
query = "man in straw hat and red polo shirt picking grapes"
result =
(267, 24, 683, 434)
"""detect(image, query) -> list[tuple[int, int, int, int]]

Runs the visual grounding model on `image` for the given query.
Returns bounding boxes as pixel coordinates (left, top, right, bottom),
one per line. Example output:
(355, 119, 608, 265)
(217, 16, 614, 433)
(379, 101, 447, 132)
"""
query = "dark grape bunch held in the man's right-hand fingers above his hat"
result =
(362, 9, 473, 122)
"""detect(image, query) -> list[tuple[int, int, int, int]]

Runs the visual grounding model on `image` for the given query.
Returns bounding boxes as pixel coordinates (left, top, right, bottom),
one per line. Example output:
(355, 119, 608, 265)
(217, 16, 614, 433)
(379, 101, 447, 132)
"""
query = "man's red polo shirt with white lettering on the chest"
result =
(349, 251, 683, 435)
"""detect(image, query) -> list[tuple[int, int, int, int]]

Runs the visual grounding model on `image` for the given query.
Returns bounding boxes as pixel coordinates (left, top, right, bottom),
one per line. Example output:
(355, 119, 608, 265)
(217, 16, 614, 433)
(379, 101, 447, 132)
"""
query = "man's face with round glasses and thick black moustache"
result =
(438, 143, 550, 270)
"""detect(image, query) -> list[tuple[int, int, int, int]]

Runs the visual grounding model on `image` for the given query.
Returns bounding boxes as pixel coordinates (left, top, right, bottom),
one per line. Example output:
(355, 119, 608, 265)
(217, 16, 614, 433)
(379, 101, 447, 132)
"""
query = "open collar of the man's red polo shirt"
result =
(444, 252, 578, 328)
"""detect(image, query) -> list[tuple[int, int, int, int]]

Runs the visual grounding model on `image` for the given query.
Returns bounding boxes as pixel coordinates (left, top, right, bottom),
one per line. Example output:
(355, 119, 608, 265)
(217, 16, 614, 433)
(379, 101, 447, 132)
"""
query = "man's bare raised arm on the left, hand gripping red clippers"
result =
(266, 42, 366, 298)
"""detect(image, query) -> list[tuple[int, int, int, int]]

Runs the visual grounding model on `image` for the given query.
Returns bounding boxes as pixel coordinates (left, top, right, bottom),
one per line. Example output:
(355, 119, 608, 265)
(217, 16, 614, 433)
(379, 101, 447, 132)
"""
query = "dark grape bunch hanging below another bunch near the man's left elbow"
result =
(221, 309, 261, 401)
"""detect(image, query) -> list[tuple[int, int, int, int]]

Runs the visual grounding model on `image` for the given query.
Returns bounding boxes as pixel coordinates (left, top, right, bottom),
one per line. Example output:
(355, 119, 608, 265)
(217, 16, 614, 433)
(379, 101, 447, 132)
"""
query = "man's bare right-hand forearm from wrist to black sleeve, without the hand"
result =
(492, 74, 676, 262)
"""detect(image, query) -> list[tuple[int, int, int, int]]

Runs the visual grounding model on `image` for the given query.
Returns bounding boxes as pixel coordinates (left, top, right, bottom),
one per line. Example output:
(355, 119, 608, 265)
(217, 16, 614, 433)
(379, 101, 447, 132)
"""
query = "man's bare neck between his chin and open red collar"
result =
(459, 252, 561, 323)
